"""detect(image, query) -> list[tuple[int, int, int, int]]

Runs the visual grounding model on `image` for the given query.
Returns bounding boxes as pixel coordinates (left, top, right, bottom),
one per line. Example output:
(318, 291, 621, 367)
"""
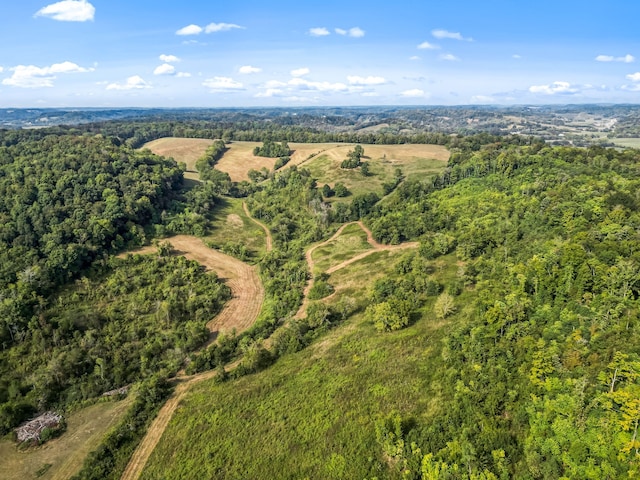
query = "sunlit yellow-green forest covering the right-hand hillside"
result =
(364, 144, 640, 479)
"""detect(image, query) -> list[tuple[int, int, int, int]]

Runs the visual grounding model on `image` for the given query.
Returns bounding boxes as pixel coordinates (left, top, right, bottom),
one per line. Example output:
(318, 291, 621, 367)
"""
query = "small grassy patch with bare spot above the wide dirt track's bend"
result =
(205, 198, 266, 259)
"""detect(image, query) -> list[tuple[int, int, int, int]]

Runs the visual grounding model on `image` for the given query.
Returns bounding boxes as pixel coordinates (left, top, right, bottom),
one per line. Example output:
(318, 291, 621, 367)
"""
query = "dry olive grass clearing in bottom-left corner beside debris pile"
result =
(0, 398, 132, 480)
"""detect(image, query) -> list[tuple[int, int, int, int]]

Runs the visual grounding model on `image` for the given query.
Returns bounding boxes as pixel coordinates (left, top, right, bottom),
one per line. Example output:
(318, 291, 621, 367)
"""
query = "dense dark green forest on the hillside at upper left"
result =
(0, 132, 182, 348)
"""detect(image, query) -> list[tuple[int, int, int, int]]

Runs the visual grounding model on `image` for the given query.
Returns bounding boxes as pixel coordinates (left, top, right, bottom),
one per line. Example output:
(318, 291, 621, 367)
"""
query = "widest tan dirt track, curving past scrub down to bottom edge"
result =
(121, 235, 264, 480)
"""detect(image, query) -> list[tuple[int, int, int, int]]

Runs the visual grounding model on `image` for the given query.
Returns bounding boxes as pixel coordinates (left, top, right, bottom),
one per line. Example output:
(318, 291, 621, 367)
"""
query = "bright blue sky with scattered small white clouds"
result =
(0, 0, 640, 107)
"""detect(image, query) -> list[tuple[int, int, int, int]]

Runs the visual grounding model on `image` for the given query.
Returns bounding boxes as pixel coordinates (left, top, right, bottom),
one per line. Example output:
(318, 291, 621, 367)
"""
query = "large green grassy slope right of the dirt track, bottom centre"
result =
(141, 251, 472, 480)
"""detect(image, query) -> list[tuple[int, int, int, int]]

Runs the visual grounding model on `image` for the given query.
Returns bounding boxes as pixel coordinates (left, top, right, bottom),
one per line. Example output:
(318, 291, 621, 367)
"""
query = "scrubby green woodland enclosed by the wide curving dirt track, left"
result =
(0, 255, 229, 433)
